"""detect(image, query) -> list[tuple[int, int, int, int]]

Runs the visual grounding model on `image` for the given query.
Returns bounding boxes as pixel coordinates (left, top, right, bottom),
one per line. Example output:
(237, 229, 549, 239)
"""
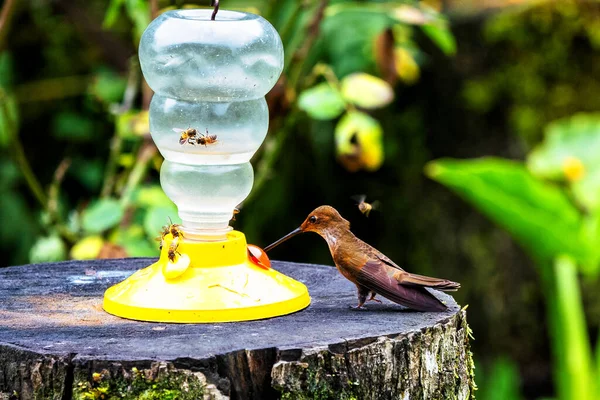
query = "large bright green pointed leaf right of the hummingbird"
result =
(426, 158, 597, 265)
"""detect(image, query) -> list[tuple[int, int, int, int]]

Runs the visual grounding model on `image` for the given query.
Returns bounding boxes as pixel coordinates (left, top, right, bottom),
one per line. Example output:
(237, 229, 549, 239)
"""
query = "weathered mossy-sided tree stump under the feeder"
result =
(0, 259, 474, 400)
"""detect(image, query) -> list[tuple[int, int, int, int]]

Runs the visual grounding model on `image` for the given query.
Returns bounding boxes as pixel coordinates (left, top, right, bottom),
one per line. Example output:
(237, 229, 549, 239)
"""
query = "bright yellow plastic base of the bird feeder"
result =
(104, 231, 310, 323)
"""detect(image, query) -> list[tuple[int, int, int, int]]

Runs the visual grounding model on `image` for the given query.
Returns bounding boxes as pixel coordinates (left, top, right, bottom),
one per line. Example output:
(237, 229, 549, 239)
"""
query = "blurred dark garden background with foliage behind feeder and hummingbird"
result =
(0, 0, 600, 400)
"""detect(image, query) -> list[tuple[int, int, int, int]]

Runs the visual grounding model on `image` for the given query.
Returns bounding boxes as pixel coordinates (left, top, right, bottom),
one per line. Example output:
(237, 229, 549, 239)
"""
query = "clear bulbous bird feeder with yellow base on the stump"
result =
(104, 10, 310, 323)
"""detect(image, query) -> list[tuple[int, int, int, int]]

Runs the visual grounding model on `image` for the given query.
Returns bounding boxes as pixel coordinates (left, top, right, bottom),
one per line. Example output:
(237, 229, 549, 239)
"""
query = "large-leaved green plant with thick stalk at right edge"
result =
(427, 114, 600, 400)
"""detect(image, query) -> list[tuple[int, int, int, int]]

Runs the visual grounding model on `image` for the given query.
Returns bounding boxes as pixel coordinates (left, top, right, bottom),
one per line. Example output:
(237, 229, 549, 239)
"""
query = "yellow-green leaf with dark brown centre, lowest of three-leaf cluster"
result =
(334, 111, 383, 172)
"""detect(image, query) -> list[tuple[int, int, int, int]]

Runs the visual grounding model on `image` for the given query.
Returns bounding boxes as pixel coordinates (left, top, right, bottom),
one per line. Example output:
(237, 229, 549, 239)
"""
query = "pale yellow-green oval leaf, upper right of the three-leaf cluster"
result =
(341, 72, 394, 109)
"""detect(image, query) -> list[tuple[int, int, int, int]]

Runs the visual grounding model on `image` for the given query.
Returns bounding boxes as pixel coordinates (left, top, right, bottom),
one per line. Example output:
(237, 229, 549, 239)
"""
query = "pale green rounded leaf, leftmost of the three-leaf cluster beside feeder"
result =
(298, 82, 346, 120)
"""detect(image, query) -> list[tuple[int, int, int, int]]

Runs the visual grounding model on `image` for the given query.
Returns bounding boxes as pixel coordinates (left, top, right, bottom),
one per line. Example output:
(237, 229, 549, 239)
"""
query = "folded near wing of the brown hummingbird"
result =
(356, 259, 448, 311)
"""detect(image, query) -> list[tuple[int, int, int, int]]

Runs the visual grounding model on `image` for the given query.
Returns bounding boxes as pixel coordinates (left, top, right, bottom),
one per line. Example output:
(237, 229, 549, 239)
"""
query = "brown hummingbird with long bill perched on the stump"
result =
(264, 206, 460, 311)
